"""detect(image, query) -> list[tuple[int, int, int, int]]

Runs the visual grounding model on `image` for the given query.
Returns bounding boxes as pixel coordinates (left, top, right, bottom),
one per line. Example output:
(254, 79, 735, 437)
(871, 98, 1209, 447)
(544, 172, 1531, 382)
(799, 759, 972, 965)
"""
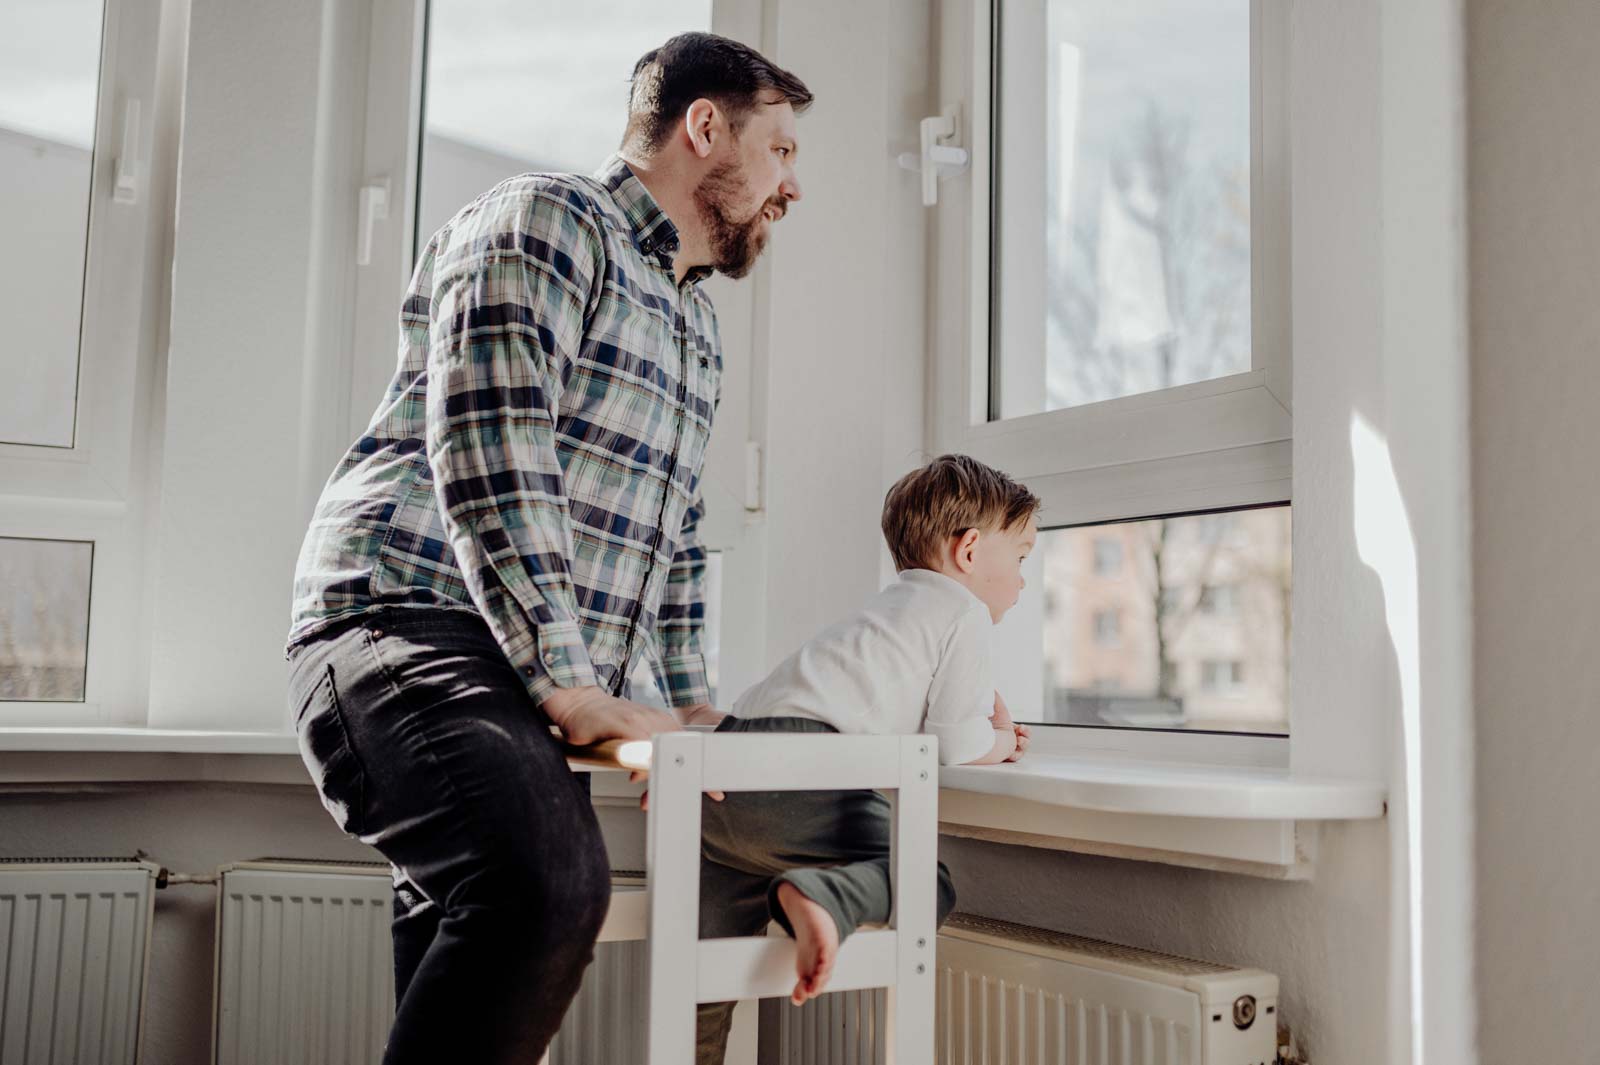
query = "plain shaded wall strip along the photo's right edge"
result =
(1466, 0, 1600, 1065)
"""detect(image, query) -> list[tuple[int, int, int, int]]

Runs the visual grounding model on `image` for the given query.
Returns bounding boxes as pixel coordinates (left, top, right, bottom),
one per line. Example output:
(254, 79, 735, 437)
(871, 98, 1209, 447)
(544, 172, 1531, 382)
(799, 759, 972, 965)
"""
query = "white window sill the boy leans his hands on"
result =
(939, 753, 1387, 880)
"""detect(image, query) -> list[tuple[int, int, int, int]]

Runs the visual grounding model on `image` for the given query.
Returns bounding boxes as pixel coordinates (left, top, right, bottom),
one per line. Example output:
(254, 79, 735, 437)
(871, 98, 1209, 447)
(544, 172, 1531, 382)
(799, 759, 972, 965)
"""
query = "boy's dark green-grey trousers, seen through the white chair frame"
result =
(694, 716, 955, 1065)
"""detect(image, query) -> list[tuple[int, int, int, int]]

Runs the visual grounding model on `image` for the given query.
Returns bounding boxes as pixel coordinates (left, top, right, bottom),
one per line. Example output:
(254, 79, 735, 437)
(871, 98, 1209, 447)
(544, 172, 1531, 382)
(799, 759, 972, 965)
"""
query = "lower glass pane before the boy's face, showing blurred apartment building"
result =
(995, 505, 1291, 734)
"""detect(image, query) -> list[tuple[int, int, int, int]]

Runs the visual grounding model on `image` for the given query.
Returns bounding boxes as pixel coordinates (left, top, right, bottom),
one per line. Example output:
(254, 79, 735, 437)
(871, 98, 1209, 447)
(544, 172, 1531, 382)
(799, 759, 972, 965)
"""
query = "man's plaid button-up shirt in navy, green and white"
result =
(290, 157, 722, 705)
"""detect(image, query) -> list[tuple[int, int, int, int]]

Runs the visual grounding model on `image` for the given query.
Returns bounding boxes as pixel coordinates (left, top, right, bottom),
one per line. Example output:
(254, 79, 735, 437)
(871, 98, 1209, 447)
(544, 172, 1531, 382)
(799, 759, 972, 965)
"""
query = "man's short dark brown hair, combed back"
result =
(622, 34, 813, 157)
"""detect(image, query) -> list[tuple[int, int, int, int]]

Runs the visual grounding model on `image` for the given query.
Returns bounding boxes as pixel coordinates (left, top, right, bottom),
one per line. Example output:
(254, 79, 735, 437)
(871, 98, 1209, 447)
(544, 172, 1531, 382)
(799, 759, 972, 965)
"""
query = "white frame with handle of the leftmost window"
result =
(0, 0, 181, 726)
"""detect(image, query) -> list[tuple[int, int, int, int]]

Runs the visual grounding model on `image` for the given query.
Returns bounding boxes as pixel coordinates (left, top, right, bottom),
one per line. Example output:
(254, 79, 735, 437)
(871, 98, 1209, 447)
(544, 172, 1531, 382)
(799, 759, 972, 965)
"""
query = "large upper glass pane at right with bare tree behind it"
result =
(990, 0, 1251, 417)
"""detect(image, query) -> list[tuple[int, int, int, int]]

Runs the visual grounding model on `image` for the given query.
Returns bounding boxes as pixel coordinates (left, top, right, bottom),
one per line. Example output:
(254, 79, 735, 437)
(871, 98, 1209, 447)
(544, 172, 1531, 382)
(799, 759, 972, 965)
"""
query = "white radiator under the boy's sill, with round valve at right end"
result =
(762, 913, 1278, 1065)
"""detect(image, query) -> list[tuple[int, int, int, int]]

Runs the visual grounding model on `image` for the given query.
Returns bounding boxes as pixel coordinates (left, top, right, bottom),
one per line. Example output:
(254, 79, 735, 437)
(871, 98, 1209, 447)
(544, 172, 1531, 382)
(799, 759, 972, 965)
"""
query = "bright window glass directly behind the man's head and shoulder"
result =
(416, 0, 710, 243)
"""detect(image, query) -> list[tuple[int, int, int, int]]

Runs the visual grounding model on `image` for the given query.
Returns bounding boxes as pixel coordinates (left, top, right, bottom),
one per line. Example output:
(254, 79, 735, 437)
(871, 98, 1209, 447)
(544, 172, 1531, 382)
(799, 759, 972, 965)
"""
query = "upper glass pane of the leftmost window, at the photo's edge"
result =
(0, 0, 102, 448)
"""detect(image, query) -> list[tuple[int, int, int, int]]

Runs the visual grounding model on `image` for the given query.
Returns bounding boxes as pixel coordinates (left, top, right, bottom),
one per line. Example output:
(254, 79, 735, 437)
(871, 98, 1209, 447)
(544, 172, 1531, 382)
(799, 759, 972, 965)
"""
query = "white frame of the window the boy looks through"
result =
(930, 0, 1293, 766)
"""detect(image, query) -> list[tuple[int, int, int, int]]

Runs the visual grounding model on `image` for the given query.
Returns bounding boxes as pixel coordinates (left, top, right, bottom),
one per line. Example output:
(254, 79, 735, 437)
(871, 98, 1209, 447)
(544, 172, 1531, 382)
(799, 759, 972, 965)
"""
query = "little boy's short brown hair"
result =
(883, 454, 1038, 571)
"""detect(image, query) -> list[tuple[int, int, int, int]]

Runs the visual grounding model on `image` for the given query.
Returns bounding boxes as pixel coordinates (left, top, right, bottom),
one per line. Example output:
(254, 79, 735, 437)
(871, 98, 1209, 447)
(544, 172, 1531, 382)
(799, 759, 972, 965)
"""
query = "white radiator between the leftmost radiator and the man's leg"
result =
(211, 860, 394, 1065)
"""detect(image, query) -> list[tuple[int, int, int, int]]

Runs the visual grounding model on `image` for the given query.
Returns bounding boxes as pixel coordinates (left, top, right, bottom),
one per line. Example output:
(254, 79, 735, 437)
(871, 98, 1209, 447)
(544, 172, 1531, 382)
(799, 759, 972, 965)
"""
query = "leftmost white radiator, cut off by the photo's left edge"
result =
(0, 859, 160, 1065)
